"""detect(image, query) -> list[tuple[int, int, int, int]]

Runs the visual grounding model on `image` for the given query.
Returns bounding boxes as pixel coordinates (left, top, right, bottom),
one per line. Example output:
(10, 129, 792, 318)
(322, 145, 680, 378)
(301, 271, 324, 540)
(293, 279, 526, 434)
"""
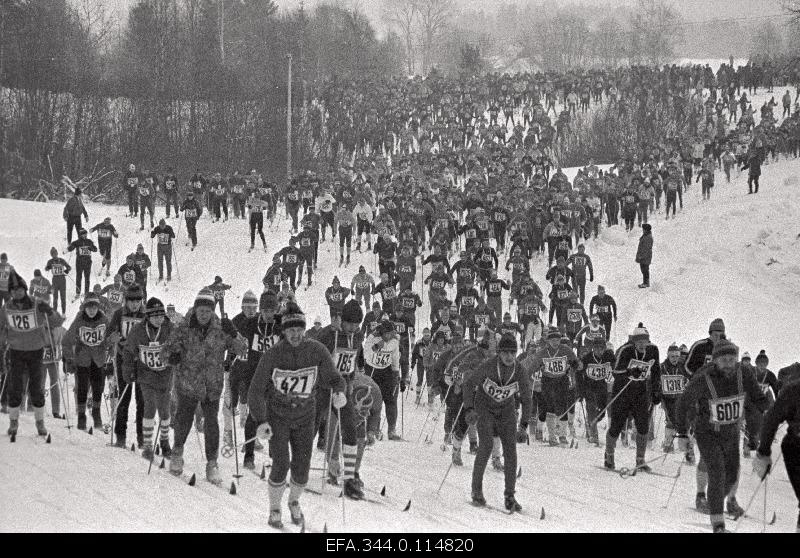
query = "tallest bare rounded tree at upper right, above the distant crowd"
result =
(630, 0, 683, 65)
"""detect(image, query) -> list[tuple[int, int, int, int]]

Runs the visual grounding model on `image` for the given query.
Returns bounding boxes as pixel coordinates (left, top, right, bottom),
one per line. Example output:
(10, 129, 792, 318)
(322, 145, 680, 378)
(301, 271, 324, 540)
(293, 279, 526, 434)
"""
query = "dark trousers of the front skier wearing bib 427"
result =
(268, 413, 316, 485)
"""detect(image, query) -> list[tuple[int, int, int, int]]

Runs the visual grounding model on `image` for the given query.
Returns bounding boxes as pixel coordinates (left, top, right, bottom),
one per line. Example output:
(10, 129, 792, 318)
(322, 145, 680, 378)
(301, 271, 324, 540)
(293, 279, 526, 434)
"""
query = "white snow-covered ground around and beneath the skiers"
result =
(0, 151, 800, 532)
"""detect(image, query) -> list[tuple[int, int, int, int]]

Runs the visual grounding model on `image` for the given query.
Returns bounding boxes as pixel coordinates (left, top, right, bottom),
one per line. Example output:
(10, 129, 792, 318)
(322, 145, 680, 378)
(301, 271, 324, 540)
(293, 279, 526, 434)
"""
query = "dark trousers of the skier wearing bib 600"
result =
(695, 432, 739, 516)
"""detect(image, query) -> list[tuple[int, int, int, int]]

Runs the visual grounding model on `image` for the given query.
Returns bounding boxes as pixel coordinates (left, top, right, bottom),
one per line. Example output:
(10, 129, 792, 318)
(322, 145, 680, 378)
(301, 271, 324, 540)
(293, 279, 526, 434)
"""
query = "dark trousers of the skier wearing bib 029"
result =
(472, 404, 517, 496)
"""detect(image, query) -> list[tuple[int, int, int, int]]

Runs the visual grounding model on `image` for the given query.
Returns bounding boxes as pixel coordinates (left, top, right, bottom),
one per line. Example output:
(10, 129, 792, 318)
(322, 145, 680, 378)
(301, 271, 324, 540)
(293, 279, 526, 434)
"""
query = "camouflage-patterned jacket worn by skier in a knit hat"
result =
(163, 312, 247, 401)
